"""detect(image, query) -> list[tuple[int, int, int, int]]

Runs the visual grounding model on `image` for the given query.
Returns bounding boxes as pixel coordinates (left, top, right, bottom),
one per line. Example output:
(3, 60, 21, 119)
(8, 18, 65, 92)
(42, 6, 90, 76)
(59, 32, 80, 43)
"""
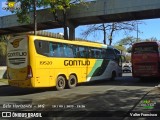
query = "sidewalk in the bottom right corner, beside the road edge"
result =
(123, 86, 160, 120)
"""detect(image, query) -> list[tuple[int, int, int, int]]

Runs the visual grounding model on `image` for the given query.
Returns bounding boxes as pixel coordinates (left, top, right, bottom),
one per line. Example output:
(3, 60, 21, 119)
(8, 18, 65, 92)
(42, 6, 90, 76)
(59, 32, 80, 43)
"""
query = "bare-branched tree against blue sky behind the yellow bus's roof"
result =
(82, 21, 142, 45)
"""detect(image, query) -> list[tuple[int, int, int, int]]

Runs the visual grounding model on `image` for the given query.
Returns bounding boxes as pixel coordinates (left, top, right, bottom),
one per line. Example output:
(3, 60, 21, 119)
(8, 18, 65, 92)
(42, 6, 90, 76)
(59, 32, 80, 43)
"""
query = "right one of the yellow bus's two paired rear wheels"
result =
(68, 75, 77, 89)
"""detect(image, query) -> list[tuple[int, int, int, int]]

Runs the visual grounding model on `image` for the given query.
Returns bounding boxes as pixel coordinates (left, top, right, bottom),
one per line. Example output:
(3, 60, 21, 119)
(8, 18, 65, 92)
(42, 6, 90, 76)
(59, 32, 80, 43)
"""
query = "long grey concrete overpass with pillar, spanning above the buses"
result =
(0, 0, 160, 39)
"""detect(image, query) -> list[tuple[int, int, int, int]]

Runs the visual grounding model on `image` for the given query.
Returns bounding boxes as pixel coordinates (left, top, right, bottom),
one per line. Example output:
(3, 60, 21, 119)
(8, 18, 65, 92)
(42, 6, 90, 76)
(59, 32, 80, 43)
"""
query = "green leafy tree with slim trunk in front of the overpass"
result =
(8, 0, 83, 39)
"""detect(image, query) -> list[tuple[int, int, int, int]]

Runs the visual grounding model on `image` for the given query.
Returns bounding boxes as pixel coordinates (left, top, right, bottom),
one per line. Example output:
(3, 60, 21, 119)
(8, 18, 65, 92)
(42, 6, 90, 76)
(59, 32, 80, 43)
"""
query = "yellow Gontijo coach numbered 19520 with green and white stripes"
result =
(7, 35, 122, 90)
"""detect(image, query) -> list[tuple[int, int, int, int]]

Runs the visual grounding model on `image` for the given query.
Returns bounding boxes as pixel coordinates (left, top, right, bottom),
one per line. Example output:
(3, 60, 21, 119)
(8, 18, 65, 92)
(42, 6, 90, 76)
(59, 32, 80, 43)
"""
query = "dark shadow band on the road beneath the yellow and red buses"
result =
(0, 76, 159, 96)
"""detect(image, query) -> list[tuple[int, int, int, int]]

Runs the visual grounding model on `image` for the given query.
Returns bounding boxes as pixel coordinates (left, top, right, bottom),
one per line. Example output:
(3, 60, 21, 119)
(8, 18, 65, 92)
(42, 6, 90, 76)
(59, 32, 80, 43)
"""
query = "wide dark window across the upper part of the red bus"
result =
(133, 46, 158, 54)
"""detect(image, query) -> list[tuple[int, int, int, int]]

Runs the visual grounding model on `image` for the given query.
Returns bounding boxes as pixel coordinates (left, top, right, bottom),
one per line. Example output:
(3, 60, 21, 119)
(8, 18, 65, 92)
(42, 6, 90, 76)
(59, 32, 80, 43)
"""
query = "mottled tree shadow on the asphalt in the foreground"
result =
(3, 88, 151, 113)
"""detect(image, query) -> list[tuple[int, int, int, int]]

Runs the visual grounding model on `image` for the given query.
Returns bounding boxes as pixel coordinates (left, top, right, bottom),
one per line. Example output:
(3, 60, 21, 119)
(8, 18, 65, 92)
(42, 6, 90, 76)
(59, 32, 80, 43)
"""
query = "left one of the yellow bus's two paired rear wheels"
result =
(56, 76, 66, 90)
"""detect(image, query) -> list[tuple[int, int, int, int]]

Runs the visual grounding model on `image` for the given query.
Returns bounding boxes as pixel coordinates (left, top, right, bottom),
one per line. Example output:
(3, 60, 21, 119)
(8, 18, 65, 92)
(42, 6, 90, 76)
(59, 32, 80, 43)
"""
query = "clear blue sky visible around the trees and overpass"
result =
(0, 0, 160, 44)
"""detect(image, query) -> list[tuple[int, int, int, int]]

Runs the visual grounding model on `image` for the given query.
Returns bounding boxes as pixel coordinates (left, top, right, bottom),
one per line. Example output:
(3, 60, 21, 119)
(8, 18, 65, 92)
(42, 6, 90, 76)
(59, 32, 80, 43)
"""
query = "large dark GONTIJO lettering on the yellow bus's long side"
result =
(64, 60, 90, 66)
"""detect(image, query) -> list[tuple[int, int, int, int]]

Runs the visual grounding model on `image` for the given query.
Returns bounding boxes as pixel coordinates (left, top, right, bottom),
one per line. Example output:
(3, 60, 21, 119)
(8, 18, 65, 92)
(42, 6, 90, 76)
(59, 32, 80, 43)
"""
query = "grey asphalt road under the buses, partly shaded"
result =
(0, 73, 159, 119)
